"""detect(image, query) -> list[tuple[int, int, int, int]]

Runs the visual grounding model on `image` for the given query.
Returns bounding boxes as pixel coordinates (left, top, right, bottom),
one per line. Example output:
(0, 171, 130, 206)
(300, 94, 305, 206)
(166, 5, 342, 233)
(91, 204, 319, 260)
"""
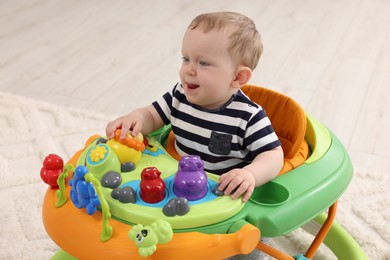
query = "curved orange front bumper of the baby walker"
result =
(42, 186, 260, 259)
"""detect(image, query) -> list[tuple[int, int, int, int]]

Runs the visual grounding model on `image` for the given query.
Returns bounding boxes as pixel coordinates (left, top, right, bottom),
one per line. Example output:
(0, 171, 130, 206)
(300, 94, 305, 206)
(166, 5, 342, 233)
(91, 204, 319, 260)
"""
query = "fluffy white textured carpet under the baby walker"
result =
(0, 92, 390, 260)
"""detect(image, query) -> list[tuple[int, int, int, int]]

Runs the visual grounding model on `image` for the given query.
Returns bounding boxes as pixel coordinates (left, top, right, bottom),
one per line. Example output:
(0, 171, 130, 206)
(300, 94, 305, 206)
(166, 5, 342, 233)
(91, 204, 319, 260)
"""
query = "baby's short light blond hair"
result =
(188, 12, 263, 70)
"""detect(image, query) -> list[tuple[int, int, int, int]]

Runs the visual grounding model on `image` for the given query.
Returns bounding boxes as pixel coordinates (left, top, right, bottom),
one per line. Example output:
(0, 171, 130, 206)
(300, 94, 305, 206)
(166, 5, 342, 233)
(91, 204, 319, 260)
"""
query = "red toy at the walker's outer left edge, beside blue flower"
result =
(41, 154, 64, 189)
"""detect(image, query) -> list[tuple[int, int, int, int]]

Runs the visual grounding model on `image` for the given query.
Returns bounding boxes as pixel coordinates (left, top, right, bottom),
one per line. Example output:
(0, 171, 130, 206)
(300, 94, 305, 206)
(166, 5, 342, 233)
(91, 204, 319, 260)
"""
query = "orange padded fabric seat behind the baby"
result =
(167, 85, 310, 175)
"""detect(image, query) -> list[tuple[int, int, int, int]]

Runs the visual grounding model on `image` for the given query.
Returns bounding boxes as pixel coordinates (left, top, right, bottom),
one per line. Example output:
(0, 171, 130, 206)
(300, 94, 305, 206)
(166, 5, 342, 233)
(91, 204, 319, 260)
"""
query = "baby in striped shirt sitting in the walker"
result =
(106, 12, 283, 202)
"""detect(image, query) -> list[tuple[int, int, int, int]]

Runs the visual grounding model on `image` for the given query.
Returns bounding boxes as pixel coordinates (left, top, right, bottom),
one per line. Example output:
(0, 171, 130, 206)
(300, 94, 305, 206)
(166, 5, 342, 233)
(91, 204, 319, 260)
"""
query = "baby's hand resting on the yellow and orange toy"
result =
(106, 113, 142, 139)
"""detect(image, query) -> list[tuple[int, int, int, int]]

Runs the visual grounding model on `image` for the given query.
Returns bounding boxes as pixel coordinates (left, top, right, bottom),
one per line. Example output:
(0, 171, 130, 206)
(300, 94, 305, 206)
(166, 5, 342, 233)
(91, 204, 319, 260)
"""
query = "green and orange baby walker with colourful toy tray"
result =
(41, 85, 367, 259)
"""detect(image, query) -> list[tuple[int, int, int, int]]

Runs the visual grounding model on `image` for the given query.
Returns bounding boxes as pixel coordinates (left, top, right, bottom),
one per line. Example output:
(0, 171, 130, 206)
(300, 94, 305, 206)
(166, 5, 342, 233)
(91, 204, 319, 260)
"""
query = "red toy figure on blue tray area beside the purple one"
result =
(140, 167, 166, 203)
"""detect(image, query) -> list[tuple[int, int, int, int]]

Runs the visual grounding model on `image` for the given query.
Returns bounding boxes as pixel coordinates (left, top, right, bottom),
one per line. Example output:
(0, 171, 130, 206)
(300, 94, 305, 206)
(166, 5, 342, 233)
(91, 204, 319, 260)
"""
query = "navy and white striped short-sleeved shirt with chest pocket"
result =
(153, 83, 280, 174)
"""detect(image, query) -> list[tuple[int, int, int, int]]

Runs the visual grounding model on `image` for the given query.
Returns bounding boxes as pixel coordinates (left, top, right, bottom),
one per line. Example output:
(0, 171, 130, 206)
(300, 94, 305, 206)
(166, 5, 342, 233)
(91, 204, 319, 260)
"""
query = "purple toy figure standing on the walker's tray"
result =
(173, 155, 207, 201)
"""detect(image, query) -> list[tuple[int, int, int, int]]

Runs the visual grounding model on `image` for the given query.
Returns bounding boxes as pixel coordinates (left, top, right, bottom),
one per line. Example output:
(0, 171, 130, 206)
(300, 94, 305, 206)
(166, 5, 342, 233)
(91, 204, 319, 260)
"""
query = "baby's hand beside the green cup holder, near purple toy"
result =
(218, 169, 255, 202)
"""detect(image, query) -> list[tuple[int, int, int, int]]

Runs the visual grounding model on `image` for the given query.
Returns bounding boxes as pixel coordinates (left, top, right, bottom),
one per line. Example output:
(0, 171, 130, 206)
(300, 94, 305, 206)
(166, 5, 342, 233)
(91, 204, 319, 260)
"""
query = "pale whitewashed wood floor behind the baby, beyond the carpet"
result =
(0, 0, 390, 173)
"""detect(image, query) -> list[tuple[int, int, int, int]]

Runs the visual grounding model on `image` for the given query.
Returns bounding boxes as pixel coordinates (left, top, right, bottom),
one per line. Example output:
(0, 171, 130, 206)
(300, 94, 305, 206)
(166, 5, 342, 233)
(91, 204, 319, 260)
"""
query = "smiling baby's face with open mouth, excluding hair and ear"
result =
(179, 28, 237, 109)
